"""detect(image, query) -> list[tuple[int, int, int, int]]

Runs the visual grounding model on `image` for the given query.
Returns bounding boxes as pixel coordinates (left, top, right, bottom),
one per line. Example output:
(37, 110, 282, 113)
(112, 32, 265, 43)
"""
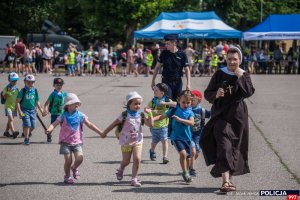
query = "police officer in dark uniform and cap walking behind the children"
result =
(151, 34, 191, 101)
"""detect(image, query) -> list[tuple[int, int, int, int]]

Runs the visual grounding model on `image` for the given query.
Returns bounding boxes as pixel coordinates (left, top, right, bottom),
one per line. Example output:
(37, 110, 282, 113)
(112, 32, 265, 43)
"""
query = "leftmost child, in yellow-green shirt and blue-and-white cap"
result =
(1, 72, 19, 139)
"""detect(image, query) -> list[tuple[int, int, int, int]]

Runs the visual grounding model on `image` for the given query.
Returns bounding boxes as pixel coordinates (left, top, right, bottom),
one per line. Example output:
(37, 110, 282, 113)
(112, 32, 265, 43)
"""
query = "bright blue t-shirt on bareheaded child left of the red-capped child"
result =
(166, 105, 194, 141)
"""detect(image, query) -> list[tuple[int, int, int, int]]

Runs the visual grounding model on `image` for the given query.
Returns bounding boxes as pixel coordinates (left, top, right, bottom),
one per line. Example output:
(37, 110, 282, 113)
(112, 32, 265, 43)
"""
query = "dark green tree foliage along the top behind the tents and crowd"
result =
(0, 0, 300, 45)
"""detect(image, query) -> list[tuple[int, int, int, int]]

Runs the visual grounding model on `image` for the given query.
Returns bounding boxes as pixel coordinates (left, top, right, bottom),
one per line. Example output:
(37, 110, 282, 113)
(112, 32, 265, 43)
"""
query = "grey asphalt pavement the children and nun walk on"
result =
(0, 74, 300, 200)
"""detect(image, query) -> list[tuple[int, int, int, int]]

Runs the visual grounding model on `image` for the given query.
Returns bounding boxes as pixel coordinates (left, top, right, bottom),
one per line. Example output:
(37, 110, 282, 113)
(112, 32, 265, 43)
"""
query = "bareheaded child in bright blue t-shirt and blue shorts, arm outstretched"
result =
(154, 90, 194, 183)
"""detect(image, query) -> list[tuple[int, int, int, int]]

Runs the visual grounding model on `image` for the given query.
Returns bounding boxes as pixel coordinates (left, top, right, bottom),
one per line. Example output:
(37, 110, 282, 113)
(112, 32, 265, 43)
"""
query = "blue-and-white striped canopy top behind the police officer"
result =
(134, 12, 242, 39)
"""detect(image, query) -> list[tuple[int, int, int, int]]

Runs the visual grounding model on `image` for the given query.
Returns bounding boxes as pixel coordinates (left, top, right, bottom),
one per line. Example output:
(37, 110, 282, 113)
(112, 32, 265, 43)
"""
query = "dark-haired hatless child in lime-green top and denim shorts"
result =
(148, 83, 169, 164)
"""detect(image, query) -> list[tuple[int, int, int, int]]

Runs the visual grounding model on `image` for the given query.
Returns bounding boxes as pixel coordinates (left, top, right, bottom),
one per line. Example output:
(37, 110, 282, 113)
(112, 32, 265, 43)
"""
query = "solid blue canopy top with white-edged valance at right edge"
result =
(243, 14, 300, 40)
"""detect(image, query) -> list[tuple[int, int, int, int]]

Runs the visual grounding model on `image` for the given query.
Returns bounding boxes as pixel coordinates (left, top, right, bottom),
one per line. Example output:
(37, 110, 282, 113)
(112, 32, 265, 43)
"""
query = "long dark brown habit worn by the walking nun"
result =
(200, 67, 255, 177)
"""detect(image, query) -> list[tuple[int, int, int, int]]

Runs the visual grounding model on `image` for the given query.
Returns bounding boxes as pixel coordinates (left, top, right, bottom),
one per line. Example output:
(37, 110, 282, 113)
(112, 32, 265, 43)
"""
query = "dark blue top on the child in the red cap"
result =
(192, 104, 210, 135)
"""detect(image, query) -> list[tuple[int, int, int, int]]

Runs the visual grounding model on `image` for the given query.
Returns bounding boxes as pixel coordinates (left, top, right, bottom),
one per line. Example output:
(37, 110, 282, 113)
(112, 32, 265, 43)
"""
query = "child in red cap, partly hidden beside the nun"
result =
(189, 90, 210, 176)
